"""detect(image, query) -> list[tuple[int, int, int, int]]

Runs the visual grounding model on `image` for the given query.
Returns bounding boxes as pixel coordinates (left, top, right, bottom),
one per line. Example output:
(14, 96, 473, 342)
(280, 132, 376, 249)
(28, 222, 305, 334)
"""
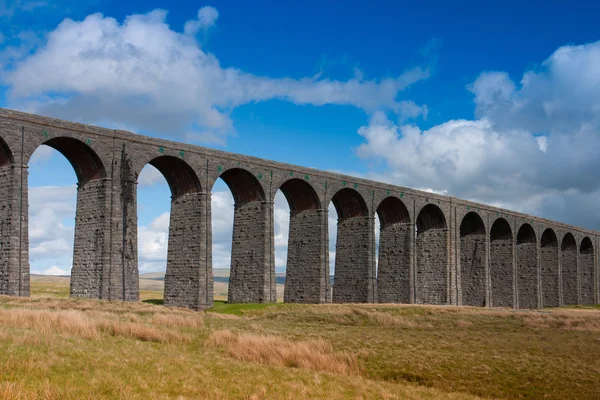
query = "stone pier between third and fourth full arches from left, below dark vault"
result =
(227, 201, 275, 303)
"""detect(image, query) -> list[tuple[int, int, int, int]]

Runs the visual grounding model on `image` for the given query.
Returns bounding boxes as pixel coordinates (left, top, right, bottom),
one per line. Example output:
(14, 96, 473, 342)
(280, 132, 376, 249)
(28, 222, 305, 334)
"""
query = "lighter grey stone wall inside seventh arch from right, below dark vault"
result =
(415, 229, 449, 304)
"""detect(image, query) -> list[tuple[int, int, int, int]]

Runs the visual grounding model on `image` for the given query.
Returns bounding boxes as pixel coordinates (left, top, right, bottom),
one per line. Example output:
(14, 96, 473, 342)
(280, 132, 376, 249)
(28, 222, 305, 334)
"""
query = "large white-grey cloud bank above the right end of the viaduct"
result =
(357, 42, 600, 228)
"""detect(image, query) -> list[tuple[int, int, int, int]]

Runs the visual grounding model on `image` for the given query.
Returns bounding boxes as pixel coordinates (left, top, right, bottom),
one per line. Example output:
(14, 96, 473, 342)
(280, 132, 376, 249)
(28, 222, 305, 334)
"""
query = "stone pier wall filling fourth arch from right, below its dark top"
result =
(517, 243, 538, 308)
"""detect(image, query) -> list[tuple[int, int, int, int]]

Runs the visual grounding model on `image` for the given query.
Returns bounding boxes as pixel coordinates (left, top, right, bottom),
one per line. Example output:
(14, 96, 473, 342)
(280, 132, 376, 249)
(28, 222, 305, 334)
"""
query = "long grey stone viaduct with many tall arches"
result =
(0, 109, 599, 309)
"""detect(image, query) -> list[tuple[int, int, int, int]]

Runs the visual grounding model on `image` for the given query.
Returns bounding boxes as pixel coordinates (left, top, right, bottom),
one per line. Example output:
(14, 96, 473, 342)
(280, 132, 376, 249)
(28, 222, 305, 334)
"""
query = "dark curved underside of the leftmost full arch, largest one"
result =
(44, 137, 106, 186)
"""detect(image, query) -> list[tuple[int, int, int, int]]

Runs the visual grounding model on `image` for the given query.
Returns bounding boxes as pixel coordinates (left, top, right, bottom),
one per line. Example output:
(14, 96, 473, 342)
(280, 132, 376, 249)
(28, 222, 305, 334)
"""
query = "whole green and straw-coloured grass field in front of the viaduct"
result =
(0, 277, 600, 399)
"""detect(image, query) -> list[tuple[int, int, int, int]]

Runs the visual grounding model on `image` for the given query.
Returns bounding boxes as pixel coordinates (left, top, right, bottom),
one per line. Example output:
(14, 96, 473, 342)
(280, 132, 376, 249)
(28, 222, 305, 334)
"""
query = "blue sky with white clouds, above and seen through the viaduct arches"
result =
(0, 0, 600, 271)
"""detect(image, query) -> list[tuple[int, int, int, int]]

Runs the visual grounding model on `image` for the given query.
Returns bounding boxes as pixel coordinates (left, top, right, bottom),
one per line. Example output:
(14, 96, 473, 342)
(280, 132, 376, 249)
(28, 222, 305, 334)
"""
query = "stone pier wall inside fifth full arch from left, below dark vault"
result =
(332, 217, 374, 303)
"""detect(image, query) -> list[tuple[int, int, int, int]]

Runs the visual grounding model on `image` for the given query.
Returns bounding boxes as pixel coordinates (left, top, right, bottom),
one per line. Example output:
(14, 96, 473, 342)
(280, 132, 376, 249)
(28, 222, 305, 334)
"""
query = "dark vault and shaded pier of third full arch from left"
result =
(219, 168, 277, 303)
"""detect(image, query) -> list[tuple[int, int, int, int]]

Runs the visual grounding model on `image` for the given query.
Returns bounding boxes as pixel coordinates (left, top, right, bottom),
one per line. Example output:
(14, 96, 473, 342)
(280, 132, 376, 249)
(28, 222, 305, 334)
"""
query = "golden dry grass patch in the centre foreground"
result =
(206, 329, 359, 375)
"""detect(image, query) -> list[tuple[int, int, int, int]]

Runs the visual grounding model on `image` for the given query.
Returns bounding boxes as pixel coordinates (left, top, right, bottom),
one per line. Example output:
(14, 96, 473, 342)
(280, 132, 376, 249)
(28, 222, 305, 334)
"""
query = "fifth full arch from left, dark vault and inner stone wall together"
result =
(331, 188, 375, 303)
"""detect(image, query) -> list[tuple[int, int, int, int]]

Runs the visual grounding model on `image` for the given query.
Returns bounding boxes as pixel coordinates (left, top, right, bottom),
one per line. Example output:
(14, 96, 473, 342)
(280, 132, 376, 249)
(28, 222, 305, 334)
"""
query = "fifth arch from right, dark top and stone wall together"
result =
(490, 218, 514, 307)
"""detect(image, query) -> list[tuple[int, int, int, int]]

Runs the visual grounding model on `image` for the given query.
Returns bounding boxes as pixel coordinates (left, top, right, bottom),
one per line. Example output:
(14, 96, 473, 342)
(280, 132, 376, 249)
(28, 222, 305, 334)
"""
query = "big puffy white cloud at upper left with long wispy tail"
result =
(4, 7, 429, 142)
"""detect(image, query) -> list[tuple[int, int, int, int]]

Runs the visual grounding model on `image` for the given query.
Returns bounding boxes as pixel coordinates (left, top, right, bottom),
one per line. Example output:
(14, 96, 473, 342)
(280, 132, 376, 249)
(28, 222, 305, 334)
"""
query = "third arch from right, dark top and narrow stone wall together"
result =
(540, 228, 559, 307)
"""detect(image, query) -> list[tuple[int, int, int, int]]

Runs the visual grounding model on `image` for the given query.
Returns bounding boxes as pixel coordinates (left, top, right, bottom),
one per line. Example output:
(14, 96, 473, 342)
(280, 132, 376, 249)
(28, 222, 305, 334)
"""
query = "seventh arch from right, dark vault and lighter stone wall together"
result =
(415, 204, 449, 304)
